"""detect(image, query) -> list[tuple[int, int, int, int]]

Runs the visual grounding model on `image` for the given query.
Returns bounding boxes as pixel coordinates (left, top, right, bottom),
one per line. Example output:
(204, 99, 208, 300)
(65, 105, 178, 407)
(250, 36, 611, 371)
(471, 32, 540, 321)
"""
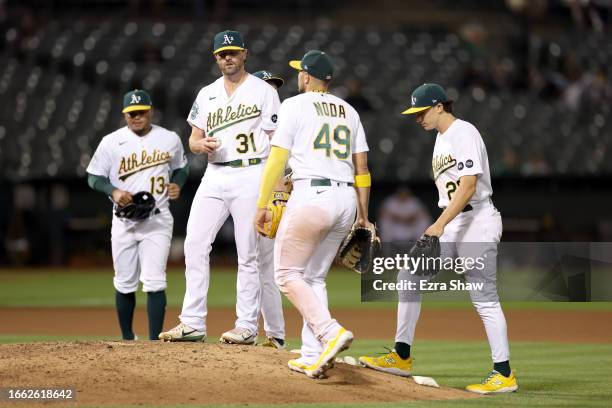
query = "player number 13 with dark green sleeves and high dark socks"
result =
(87, 89, 188, 340)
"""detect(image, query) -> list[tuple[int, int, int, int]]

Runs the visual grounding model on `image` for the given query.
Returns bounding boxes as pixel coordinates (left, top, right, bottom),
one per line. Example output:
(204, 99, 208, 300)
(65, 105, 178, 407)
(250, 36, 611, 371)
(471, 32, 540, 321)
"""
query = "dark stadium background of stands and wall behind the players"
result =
(0, 0, 612, 266)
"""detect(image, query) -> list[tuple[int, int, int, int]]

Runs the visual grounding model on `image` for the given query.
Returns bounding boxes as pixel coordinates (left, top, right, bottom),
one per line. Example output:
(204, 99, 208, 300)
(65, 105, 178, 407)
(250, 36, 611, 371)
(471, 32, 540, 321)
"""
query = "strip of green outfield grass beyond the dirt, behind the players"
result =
(0, 268, 612, 311)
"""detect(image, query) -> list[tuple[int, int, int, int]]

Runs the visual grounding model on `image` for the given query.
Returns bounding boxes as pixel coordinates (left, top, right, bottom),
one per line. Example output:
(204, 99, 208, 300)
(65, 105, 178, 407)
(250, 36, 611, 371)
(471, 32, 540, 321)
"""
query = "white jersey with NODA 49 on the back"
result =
(270, 92, 369, 183)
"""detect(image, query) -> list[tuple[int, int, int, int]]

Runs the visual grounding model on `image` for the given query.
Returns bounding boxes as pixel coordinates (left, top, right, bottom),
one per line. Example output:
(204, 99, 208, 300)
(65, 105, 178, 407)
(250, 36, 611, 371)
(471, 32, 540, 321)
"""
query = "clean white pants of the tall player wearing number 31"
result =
(180, 163, 264, 333)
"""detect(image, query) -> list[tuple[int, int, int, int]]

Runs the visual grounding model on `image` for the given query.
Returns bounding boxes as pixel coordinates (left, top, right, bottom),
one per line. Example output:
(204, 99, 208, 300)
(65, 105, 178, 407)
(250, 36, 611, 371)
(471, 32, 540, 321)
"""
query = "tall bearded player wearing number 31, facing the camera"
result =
(160, 30, 280, 344)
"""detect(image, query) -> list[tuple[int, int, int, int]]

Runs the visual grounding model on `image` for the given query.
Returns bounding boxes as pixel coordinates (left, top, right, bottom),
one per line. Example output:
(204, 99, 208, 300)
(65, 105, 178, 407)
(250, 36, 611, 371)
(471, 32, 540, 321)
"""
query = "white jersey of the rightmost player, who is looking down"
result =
(431, 119, 493, 208)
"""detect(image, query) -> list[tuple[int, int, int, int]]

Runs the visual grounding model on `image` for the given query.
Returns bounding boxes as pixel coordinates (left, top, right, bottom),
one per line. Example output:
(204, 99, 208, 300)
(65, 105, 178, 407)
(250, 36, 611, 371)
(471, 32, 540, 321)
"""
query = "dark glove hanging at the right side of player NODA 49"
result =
(338, 225, 380, 273)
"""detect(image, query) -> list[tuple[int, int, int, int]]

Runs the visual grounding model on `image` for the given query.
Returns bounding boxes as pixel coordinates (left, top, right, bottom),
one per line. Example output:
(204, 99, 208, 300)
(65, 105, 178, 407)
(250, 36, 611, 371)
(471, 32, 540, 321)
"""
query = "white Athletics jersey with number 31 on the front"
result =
(187, 74, 280, 163)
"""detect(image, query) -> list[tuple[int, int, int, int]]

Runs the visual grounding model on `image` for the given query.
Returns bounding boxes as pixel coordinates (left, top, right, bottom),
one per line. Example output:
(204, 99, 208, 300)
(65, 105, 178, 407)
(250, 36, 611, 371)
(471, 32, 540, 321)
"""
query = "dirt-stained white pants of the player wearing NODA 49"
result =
(274, 180, 357, 363)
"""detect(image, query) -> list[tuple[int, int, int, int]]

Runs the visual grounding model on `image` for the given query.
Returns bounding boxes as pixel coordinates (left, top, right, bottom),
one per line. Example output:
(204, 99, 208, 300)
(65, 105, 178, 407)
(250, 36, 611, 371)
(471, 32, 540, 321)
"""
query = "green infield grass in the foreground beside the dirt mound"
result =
(0, 336, 612, 408)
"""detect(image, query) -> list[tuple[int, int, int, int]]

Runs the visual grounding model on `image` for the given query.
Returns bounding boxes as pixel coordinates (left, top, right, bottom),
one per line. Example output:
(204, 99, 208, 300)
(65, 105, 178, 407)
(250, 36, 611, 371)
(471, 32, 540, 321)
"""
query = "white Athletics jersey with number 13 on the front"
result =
(87, 125, 187, 209)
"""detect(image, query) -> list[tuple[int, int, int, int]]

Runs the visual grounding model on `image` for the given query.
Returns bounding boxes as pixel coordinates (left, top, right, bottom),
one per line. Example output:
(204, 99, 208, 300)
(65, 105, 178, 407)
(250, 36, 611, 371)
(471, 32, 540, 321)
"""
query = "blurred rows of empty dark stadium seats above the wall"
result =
(0, 18, 612, 182)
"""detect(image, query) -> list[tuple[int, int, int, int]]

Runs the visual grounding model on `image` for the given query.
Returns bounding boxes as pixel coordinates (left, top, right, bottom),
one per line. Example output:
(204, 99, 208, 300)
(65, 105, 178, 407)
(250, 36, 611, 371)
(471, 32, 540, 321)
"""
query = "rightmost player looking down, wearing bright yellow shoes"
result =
(359, 84, 518, 394)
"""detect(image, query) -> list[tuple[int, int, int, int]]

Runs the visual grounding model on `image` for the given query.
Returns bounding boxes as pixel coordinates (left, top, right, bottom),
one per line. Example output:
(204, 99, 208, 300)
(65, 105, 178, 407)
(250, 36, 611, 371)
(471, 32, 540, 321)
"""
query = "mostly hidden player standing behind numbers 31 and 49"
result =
(253, 71, 286, 350)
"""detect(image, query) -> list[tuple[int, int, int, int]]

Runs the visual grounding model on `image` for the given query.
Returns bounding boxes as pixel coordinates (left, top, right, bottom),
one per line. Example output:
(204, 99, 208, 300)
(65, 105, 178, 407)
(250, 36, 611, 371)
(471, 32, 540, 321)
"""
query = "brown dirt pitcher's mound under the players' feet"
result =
(0, 341, 475, 406)
